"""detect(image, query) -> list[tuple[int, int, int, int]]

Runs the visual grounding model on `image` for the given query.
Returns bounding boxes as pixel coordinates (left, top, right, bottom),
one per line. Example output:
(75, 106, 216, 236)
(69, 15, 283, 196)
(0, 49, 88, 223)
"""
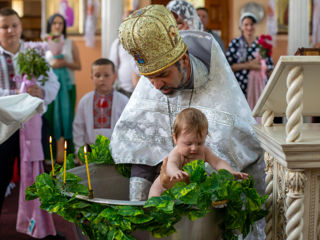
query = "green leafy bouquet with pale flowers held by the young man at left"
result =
(14, 43, 50, 92)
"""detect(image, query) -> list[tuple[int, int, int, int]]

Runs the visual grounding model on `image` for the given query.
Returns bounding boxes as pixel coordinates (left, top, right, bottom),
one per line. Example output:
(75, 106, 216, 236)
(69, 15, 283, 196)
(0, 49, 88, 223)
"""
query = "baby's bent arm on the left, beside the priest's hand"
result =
(167, 152, 188, 180)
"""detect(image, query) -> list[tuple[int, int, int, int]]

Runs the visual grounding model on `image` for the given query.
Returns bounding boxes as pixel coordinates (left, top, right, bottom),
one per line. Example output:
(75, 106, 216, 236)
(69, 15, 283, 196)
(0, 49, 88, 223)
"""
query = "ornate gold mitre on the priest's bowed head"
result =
(119, 5, 187, 76)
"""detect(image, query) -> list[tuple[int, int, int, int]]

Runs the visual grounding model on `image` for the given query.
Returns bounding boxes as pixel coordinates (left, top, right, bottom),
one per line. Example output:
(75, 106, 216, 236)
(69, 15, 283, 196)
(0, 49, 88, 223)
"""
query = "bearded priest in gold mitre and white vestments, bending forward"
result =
(111, 5, 264, 205)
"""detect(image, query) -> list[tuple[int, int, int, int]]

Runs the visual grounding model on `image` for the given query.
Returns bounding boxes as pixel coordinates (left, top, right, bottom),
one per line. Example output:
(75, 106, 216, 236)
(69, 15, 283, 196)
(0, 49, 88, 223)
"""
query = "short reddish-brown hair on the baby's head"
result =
(173, 108, 208, 142)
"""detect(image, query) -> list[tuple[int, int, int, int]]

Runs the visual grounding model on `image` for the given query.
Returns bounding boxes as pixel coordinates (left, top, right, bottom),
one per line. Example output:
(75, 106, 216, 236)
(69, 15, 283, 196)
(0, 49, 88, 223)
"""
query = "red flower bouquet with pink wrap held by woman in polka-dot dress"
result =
(247, 34, 272, 122)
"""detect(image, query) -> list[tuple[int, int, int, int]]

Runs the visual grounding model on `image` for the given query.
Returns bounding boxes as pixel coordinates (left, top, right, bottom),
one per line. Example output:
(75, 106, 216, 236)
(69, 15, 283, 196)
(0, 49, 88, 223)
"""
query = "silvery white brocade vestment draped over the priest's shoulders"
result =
(110, 31, 262, 171)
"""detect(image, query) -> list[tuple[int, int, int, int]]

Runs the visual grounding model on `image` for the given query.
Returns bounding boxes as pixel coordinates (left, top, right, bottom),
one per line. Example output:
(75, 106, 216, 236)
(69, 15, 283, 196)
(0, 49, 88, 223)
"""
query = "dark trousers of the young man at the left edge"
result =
(0, 130, 20, 214)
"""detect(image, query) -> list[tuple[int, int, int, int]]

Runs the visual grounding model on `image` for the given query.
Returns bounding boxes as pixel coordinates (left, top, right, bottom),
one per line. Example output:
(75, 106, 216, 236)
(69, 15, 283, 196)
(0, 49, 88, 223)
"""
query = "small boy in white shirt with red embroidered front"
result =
(73, 58, 128, 156)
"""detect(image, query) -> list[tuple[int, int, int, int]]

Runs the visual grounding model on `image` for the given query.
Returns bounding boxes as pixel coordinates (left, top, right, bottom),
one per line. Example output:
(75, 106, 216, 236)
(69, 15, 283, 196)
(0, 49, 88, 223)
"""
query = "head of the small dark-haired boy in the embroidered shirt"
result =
(91, 58, 117, 95)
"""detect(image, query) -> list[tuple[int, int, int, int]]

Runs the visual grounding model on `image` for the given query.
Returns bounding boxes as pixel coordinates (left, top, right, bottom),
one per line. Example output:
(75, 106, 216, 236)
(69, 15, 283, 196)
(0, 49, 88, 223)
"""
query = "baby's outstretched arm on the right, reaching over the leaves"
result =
(205, 147, 249, 179)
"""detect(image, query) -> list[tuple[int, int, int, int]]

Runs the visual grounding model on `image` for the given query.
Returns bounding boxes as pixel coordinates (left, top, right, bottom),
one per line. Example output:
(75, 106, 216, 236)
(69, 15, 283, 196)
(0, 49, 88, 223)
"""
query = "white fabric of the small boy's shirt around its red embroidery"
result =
(72, 91, 128, 152)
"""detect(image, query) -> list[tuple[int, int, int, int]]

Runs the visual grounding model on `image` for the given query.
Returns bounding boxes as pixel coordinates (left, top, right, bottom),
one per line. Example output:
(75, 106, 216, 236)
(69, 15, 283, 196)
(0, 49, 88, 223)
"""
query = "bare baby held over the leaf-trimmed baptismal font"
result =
(148, 108, 248, 198)
